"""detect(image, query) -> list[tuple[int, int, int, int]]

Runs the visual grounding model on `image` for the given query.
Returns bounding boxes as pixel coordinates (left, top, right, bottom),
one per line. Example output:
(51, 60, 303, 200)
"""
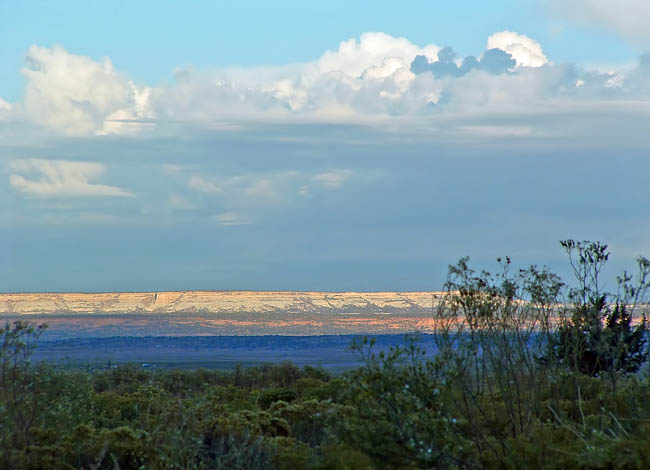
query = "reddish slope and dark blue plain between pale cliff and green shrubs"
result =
(0, 312, 435, 372)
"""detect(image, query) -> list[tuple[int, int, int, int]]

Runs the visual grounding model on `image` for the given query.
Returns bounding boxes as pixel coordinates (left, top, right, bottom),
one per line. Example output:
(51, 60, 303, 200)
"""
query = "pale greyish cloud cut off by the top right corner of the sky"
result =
(550, 0, 650, 46)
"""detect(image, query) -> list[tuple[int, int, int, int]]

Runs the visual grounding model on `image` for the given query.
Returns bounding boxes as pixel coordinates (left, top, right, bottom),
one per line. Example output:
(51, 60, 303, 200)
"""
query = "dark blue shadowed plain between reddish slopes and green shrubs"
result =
(34, 334, 435, 372)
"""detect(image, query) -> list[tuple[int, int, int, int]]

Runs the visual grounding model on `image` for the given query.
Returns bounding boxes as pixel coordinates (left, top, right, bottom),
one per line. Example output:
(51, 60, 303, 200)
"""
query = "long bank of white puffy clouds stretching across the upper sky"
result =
(11, 31, 650, 141)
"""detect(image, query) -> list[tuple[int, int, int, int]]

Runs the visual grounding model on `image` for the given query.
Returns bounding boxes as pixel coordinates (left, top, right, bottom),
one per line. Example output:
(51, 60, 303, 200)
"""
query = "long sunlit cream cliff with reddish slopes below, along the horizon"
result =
(0, 291, 443, 338)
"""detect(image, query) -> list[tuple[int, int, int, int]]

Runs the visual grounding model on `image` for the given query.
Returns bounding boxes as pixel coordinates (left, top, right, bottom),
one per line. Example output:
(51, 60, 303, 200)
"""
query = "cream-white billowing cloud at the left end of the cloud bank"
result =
(22, 46, 149, 135)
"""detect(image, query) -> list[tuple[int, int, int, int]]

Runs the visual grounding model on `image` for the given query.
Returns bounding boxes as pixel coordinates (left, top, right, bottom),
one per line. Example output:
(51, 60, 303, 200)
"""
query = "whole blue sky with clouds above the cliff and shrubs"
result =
(0, 0, 650, 292)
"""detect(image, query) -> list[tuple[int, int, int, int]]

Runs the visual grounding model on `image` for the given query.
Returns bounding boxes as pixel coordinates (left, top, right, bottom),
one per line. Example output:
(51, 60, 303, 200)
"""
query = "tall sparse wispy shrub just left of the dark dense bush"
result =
(434, 258, 563, 467)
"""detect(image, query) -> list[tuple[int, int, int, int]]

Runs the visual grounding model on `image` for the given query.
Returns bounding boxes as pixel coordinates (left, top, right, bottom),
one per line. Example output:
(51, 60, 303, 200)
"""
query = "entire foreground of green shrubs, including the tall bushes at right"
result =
(0, 240, 650, 470)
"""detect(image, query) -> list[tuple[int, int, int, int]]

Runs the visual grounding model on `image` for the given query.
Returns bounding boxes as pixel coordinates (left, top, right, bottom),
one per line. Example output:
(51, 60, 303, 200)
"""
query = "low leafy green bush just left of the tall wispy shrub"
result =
(343, 338, 469, 468)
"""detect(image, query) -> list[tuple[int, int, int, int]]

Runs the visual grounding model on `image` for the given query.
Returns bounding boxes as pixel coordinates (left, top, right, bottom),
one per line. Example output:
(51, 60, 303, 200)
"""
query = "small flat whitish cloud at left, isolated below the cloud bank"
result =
(9, 159, 132, 197)
